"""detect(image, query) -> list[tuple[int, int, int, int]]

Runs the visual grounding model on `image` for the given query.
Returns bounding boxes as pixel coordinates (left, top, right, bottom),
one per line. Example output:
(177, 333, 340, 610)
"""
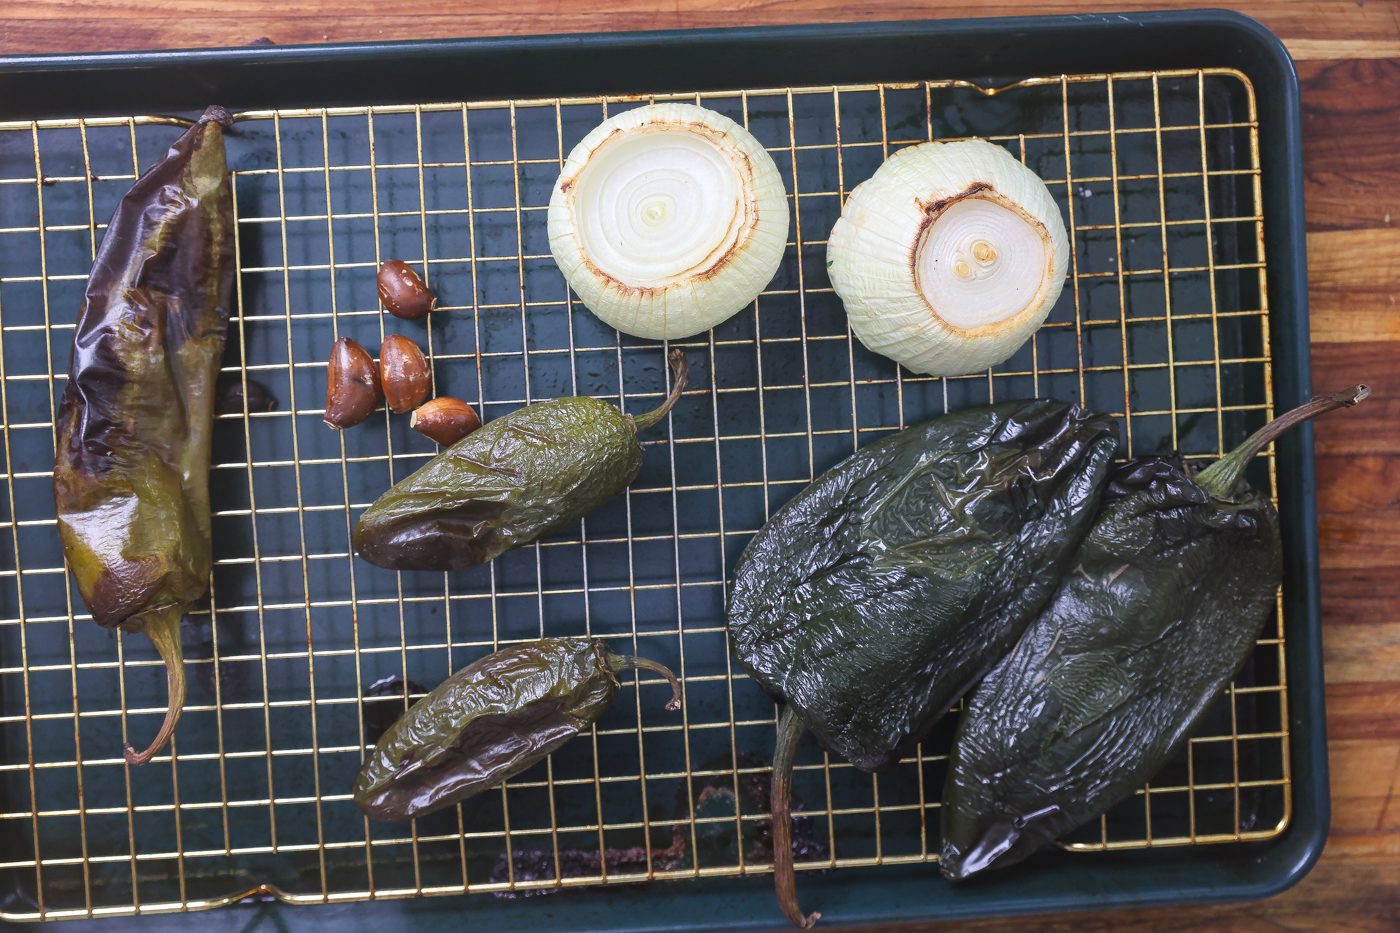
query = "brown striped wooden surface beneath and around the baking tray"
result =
(0, 0, 1400, 933)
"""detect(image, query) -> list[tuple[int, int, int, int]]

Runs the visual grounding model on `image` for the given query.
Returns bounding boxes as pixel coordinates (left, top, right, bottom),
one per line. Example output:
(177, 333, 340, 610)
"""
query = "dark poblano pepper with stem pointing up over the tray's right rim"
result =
(941, 387, 1368, 880)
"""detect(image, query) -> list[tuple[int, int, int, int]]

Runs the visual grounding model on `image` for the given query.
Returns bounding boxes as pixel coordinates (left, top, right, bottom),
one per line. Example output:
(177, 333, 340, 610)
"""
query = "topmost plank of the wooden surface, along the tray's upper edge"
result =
(0, 0, 1400, 60)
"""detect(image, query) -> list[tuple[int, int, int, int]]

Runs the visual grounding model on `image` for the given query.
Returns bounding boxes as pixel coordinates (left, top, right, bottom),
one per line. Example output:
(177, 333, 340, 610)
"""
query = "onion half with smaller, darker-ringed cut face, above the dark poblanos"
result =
(826, 140, 1070, 375)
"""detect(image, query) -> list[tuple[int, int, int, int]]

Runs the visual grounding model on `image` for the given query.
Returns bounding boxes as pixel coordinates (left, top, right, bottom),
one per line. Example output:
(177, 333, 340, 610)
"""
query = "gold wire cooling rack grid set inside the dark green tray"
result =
(0, 70, 1291, 920)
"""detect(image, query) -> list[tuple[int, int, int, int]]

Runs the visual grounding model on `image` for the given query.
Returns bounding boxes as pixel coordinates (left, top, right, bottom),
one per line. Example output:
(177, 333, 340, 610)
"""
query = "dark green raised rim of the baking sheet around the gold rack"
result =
(0, 11, 1329, 930)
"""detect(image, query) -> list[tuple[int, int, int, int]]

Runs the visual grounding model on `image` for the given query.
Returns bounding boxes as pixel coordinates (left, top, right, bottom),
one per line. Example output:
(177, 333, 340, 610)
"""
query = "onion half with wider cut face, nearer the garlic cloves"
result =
(549, 104, 788, 340)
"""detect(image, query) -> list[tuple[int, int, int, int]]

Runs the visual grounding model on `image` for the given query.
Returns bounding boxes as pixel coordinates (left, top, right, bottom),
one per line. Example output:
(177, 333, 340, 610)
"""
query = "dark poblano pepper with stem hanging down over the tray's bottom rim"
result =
(728, 399, 1117, 926)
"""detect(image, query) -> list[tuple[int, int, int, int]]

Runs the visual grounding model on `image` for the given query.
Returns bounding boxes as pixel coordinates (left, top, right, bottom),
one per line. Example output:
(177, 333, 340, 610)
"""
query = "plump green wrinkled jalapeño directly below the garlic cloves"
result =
(354, 350, 686, 570)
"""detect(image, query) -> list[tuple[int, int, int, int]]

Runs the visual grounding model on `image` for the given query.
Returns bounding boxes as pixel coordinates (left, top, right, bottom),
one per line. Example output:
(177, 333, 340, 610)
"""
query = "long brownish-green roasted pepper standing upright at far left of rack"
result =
(53, 106, 234, 765)
